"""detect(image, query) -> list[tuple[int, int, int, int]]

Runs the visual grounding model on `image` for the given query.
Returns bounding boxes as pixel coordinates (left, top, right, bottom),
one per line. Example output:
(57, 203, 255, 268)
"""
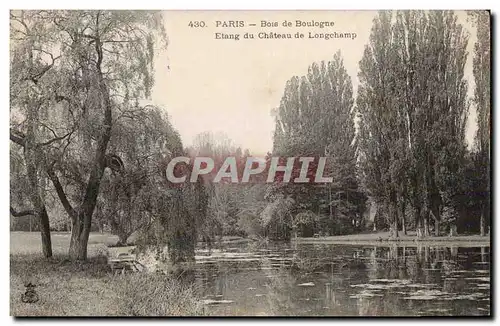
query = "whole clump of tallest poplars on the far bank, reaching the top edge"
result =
(358, 11, 468, 235)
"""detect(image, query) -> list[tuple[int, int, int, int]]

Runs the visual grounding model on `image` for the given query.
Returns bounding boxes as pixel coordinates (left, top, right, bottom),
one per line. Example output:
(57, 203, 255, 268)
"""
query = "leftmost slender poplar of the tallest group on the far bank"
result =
(357, 11, 404, 237)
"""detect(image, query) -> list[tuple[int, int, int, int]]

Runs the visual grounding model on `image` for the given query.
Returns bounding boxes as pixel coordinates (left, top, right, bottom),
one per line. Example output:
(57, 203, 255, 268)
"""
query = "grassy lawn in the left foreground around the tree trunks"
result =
(10, 232, 203, 317)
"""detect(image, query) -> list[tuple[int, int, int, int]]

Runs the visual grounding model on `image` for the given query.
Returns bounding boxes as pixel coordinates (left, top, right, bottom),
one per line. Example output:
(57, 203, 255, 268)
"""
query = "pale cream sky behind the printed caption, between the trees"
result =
(152, 11, 476, 156)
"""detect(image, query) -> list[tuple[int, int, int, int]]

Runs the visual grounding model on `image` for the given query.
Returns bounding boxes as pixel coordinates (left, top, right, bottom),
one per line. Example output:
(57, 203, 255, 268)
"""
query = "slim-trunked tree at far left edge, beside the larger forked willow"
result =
(10, 11, 63, 257)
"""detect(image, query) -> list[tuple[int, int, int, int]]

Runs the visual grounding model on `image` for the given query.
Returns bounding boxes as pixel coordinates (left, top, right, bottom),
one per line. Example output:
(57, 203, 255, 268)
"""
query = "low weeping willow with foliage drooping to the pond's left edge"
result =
(133, 153, 209, 271)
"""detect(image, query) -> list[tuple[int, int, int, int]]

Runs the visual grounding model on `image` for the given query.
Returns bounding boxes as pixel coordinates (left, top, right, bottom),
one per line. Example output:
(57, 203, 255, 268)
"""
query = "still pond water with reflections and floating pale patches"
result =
(196, 243, 490, 316)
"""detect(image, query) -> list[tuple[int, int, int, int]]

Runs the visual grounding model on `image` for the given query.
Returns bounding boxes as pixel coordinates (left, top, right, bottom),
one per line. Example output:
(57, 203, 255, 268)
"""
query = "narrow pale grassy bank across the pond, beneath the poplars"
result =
(292, 231, 490, 247)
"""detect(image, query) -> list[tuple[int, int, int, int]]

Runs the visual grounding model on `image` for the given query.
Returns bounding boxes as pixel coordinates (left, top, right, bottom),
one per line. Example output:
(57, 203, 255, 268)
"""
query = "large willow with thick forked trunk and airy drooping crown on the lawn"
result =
(11, 10, 166, 259)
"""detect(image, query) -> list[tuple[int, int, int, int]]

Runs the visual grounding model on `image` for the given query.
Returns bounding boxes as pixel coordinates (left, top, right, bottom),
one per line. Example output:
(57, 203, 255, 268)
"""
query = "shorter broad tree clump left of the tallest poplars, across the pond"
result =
(271, 52, 363, 233)
